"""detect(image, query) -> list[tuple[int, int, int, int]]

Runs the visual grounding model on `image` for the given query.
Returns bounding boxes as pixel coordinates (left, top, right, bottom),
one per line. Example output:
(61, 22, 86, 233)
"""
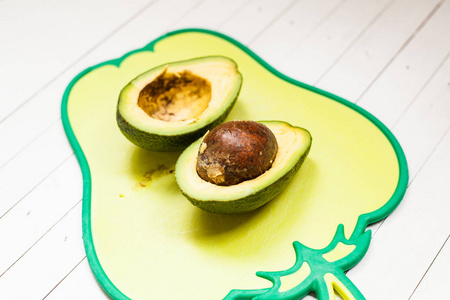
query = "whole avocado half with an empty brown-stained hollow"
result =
(116, 56, 242, 151)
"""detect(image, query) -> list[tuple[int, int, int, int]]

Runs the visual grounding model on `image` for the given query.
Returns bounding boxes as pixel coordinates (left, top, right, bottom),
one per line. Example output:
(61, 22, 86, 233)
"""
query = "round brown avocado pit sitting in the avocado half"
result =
(197, 121, 278, 186)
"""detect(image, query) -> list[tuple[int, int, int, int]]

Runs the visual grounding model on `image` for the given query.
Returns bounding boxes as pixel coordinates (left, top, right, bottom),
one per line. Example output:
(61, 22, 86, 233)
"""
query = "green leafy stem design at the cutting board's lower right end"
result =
(225, 225, 371, 300)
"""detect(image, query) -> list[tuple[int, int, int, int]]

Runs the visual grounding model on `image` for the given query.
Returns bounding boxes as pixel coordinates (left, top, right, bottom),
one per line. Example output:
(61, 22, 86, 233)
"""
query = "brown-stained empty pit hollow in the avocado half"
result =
(138, 68, 211, 122)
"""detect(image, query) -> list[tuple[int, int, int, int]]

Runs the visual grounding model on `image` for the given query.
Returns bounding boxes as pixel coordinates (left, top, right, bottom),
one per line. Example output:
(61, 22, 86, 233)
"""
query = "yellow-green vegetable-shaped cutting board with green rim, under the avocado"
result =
(62, 29, 408, 299)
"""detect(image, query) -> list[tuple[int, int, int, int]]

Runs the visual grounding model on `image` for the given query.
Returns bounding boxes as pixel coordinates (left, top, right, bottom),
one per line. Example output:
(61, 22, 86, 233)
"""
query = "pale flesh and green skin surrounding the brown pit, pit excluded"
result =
(175, 121, 312, 214)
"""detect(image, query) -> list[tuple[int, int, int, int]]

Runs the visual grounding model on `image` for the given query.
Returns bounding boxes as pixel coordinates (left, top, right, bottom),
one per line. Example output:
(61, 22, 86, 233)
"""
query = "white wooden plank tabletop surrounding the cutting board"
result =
(0, 0, 450, 300)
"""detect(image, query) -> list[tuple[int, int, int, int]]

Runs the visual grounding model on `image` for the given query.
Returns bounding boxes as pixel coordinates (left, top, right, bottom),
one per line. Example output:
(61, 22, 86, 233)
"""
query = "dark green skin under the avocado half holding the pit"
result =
(181, 144, 311, 214)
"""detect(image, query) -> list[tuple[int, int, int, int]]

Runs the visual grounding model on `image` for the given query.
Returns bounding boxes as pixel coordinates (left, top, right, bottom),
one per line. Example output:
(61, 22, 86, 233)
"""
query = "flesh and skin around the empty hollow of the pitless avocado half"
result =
(116, 56, 242, 152)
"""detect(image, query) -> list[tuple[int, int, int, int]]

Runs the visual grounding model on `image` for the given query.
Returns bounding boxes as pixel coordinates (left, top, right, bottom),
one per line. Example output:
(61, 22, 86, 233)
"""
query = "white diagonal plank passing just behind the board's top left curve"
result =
(0, 1, 200, 172)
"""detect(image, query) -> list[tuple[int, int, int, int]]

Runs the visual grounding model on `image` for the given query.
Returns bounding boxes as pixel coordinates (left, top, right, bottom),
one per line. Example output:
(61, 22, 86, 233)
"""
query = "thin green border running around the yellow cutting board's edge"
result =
(61, 28, 409, 299)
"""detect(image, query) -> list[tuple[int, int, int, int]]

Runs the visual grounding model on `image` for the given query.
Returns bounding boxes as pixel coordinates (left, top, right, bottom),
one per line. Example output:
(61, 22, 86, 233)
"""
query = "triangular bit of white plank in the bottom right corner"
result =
(411, 235, 450, 300)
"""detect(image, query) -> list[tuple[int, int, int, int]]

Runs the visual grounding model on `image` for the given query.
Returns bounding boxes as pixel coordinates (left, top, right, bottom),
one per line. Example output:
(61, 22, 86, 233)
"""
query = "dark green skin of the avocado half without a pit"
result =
(116, 92, 239, 152)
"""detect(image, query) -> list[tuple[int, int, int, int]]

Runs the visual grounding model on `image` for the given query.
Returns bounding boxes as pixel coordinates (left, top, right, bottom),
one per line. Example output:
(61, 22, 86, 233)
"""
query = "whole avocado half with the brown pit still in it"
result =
(175, 121, 312, 214)
